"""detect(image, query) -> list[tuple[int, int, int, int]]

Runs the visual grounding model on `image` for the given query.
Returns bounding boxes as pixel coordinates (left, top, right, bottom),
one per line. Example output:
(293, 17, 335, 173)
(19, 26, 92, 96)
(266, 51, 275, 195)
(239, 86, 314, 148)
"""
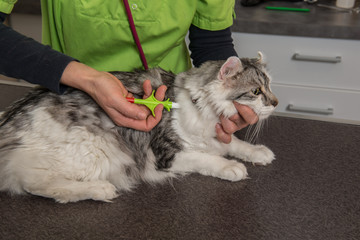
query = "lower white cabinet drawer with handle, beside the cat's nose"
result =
(272, 84, 360, 124)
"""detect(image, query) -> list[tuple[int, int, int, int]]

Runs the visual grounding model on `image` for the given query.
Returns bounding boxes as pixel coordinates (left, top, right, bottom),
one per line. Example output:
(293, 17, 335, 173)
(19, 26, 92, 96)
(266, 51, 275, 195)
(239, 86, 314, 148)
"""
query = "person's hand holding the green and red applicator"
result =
(61, 62, 166, 131)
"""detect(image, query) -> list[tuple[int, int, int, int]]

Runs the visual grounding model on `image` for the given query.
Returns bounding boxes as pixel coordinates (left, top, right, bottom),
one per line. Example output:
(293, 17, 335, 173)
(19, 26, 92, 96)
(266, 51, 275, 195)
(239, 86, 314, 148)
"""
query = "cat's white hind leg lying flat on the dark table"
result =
(24, 177, 118, 203)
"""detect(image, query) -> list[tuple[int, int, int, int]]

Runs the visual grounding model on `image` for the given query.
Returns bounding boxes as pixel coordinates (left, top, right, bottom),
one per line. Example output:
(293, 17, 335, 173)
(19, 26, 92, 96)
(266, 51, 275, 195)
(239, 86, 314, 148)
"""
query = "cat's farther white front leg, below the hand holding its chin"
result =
(227, 137, 275, 165)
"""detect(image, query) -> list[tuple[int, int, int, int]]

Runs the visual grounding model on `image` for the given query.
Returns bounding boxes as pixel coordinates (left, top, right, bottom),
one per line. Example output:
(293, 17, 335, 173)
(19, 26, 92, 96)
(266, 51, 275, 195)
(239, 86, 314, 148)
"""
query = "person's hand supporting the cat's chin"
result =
(215, 102, 259, 144)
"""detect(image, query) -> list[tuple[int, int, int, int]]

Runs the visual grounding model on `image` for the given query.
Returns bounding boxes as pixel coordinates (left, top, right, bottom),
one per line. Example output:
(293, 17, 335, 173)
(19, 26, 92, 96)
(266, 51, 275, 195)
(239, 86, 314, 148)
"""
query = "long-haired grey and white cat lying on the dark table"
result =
(0, 53, 278, 203)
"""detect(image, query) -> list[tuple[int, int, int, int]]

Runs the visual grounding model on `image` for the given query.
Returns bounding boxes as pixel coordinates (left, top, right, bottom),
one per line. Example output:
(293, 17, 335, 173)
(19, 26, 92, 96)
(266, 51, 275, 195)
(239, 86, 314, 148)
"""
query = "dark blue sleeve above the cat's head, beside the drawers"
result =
(189, 25, 237, 67)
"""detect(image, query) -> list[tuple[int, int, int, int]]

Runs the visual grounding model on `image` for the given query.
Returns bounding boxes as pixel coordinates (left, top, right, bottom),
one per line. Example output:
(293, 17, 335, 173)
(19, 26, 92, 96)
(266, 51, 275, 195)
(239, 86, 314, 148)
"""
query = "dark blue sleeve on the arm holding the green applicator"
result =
(0, 13, 76, 93)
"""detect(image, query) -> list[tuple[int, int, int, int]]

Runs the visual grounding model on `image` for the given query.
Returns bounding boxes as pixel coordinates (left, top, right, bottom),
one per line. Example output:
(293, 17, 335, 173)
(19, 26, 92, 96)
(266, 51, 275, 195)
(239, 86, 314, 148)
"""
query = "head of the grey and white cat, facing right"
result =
(205, 52, 278, 120)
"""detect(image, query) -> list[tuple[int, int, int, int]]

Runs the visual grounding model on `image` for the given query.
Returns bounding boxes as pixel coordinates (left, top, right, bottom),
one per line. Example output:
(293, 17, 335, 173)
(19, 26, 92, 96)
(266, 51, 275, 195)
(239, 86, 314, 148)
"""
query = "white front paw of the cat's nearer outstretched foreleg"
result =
(218, 160, 247, 182)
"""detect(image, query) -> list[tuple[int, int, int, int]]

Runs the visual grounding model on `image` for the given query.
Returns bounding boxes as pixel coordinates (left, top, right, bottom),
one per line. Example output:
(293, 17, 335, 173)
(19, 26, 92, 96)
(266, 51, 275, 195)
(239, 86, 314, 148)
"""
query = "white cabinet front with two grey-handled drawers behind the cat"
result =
(233, 33, 360, 124)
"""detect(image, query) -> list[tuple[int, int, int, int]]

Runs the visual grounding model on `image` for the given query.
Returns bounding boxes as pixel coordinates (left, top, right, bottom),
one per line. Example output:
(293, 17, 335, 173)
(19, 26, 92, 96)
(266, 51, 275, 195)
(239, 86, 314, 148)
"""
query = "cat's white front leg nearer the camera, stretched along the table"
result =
(169, 152, 247, 181)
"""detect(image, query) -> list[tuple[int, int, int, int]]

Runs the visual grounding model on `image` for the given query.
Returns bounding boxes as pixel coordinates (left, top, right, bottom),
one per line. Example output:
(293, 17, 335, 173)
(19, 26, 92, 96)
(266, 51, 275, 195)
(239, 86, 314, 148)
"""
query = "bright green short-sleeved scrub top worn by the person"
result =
(0, 0, 235, 73)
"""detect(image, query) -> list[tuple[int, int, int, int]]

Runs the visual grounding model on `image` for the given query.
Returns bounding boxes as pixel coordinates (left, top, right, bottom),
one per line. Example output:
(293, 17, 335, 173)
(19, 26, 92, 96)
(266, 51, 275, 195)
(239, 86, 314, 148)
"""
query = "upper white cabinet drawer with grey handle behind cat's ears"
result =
(233, 33, 360, 91)
